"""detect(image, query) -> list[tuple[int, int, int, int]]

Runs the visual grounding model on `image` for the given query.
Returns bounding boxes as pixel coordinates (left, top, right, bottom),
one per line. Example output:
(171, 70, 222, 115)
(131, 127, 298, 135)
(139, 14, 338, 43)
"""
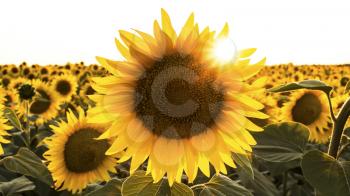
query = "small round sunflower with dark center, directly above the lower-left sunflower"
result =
(51, 74, 78, 102)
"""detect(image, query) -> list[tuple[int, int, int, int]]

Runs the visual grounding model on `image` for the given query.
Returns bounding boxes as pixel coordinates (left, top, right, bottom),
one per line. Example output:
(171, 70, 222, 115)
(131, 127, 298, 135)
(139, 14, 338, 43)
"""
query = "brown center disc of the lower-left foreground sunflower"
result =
(64, 127, 109, 173)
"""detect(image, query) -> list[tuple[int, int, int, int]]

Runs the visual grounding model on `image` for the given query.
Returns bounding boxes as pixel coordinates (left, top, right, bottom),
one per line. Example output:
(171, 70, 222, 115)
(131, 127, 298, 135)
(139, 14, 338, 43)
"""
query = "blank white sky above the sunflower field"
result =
(0, 0, 350, 64)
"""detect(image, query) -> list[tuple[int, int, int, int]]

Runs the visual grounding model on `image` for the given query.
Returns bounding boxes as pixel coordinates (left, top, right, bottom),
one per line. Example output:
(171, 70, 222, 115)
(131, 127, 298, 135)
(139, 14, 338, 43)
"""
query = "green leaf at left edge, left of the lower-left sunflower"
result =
(1, 148, 53, 185)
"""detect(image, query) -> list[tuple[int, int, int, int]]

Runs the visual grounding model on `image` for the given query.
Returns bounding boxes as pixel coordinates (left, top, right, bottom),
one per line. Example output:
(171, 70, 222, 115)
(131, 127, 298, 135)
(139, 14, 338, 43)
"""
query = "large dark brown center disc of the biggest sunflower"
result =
(134, 53, 224, 139)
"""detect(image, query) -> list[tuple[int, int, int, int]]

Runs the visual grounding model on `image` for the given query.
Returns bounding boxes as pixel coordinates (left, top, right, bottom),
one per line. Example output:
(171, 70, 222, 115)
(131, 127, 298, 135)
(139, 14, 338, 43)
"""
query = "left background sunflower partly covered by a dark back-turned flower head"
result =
(19, 80, 61, 125)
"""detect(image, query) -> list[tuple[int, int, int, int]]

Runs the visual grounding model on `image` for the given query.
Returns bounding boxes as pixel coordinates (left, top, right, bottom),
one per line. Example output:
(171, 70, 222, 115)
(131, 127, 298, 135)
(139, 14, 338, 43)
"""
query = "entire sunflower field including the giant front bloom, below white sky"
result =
(0, 9, 350, 196)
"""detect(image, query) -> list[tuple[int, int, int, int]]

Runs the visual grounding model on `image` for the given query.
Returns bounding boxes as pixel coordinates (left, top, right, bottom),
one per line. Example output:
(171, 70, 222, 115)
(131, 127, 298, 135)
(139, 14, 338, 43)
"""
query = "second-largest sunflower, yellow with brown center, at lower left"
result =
(44, 108, 117, 193)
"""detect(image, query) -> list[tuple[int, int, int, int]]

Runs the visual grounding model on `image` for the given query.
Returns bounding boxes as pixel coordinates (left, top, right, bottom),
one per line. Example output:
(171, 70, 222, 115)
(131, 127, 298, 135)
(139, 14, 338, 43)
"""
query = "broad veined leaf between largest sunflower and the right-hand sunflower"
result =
(253, 122, 309, 162)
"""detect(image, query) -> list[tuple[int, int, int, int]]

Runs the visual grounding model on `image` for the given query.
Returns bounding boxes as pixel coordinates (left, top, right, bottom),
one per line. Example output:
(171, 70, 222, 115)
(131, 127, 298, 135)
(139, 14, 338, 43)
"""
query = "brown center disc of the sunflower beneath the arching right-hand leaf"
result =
(292, 93, 322, 125)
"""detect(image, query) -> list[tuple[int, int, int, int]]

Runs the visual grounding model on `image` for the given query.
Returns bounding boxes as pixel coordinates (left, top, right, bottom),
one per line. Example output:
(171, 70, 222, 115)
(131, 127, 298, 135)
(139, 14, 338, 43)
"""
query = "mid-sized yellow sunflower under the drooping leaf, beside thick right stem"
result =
(281, 90, 331, 143)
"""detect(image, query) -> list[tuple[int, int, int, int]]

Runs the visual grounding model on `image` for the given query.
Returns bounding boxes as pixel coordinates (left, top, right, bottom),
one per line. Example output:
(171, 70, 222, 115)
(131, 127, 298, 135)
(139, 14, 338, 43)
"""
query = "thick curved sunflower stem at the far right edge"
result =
(328, 98, 350, 158)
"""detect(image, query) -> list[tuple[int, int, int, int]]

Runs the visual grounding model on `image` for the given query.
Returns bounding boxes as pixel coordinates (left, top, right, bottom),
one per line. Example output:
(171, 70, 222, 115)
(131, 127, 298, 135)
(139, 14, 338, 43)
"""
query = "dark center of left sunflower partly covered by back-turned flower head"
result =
(29, 89, 51, 114)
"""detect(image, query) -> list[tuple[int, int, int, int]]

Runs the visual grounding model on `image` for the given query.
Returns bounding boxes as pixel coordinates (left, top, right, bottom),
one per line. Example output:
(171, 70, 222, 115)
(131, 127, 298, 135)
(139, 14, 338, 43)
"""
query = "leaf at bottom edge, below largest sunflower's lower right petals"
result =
(193, 174, 253, 196)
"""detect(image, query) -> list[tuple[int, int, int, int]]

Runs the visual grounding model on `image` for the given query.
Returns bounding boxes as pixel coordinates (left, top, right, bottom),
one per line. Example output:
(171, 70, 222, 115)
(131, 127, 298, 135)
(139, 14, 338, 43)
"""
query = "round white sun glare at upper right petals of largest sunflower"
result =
(213, 38, 237, 64)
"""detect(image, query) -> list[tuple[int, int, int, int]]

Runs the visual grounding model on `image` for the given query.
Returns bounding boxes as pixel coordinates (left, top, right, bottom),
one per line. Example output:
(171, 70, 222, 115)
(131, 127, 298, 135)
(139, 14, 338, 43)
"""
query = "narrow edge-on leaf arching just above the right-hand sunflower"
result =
(267, 80, 333, 94)
